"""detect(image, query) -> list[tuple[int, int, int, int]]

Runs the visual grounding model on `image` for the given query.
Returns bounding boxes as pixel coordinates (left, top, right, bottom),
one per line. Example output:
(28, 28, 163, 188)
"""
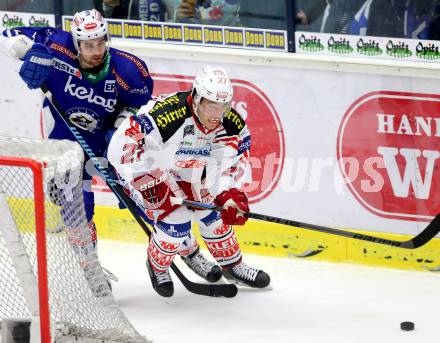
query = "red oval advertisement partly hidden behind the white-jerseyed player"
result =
(152, 74, 284, 203)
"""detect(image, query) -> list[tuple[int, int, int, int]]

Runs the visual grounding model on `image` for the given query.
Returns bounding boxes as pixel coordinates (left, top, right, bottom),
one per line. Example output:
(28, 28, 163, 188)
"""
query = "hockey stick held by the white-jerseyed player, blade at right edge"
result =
(171, 197, 440, 249)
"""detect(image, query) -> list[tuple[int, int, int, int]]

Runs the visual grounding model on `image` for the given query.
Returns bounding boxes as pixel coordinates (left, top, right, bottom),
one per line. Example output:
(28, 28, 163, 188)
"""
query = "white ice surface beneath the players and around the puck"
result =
(99, 241, 440, 343)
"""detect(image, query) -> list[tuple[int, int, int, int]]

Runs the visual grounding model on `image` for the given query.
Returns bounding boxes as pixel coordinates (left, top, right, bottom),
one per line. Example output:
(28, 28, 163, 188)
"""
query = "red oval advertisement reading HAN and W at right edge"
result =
(337, 91, 440, 220)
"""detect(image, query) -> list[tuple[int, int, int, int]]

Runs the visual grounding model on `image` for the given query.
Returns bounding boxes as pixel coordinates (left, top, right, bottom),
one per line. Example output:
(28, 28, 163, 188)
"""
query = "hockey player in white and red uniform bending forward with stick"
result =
(108, 66, 270, 297)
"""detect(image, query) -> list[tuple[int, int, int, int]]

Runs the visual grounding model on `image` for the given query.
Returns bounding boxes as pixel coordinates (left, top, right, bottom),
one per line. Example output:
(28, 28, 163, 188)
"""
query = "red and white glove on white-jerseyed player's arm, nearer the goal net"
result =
(131, 170, 178, 218)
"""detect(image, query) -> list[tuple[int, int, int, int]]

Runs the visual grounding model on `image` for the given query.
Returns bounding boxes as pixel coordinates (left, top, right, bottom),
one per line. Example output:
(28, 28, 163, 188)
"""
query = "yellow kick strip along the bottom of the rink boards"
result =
(95, 206, 440, 271)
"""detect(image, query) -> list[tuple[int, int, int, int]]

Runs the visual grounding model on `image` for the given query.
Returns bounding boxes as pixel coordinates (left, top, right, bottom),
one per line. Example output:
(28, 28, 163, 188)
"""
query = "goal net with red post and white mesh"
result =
(0, 136, 147, 343)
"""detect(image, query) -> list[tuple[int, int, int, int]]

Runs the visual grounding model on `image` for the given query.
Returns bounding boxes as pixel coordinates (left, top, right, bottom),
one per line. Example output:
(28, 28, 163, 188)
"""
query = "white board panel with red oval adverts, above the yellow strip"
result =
(0, 50, 440, 235)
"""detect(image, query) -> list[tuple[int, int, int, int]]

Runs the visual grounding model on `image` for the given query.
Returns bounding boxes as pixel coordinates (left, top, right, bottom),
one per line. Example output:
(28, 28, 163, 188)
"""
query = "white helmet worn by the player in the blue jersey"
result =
(70, 9, 110, 53)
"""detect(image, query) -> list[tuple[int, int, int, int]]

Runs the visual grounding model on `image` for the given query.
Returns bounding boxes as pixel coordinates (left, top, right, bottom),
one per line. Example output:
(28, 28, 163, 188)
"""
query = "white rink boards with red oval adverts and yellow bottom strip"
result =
(0, 39, 440, 270)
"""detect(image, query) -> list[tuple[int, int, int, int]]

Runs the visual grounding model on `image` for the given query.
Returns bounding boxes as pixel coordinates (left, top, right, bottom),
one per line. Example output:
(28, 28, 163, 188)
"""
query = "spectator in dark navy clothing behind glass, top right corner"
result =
(350, 0, 438, 39)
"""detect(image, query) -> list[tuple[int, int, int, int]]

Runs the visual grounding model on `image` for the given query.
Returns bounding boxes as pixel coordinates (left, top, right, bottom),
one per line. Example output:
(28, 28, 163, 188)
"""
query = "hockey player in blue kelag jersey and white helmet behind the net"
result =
(2, 9, 153, 250)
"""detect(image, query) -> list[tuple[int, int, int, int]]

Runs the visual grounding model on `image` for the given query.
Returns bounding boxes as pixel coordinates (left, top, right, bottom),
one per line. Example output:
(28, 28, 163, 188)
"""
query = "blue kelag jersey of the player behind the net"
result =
(3, 27, 153, 156)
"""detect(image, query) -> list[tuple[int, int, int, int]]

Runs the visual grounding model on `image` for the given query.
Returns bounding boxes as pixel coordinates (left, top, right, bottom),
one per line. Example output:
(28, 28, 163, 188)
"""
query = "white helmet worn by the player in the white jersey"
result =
(192, 66, 234, 116)
